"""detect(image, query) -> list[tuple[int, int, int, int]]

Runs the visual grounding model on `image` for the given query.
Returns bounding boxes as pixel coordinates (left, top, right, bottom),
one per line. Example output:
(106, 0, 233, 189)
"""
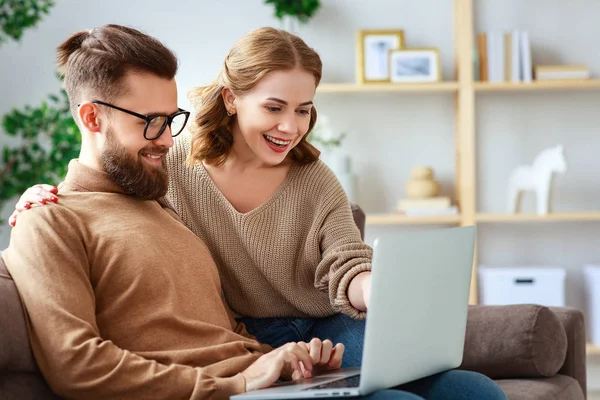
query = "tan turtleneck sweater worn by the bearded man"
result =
(2, 161, 269, 399)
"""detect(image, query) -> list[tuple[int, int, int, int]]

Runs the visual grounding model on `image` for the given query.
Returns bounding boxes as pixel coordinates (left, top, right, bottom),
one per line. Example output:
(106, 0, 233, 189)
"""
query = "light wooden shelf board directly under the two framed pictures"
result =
(317, 82, 458, 93)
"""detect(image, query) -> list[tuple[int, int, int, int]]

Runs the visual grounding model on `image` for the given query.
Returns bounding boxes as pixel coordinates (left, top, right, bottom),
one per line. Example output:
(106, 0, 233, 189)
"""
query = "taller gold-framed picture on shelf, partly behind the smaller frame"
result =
(356, 30, 404, 83)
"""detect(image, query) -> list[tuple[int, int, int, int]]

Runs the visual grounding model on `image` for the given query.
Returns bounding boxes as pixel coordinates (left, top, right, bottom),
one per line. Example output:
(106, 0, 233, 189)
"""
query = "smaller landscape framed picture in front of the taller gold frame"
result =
(390, 49, 442, 83)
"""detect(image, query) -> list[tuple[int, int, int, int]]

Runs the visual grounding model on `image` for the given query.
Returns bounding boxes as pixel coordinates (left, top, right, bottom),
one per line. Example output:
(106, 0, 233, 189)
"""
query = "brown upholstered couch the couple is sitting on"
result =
(0, 206, 587, 400)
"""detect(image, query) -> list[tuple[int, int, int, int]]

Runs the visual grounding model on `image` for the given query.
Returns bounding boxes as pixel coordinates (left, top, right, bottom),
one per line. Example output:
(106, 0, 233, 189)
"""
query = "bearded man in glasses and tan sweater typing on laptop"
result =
(3, 25, 343, 399)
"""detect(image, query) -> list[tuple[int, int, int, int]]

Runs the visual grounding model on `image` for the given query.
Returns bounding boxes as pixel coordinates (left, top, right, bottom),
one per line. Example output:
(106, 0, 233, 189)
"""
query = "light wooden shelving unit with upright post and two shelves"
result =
(317, 0, 600, 312)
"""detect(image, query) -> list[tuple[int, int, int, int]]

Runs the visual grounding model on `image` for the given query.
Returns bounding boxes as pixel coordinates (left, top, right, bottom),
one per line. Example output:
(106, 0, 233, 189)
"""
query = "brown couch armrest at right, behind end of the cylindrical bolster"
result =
(550, 307, 587, 398)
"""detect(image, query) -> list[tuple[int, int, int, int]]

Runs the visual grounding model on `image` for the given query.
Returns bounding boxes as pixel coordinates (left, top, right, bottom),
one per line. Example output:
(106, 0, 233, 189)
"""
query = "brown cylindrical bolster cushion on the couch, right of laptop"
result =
(460, 305, 567, 379)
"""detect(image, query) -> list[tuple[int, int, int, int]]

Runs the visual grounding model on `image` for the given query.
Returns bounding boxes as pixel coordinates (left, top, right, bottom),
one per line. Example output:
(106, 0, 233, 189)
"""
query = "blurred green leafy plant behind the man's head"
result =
(0, 90, 81, 217)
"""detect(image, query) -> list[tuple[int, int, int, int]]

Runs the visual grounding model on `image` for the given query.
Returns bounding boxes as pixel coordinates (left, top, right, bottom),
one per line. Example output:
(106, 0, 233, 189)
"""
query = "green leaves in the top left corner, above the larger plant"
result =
(0, 0, 54, 43)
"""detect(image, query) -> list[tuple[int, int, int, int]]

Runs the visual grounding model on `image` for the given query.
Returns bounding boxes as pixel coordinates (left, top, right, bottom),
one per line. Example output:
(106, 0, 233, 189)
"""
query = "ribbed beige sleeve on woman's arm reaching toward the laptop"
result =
(315, 177, 373, 319)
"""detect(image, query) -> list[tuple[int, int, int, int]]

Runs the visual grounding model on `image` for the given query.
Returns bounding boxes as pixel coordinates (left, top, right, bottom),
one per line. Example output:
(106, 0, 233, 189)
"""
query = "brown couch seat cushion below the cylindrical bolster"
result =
(496, 375, 585, 400)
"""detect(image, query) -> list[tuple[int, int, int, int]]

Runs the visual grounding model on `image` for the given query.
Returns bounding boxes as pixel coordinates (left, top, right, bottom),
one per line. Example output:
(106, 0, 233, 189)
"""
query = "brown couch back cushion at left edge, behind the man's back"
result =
(0, 252, 38, 374)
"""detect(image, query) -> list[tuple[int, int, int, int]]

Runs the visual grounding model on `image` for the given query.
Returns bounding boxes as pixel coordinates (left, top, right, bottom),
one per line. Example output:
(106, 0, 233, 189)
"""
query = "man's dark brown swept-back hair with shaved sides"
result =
(57, 25, 177, 120)
